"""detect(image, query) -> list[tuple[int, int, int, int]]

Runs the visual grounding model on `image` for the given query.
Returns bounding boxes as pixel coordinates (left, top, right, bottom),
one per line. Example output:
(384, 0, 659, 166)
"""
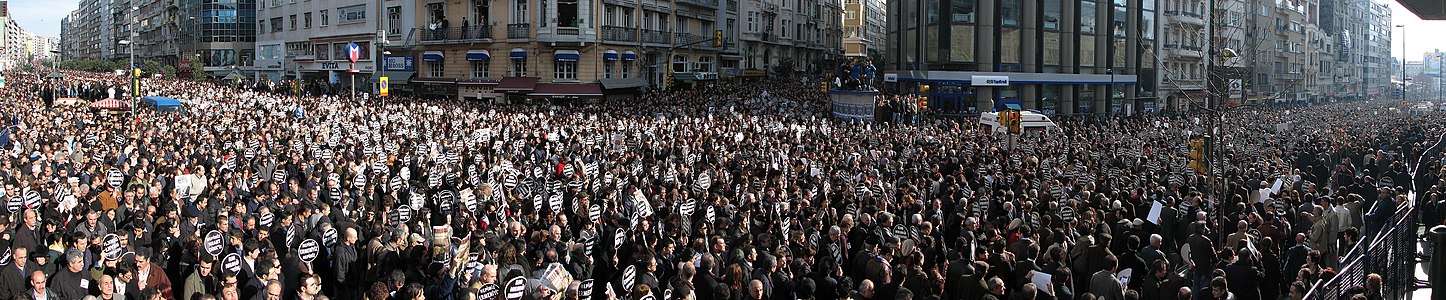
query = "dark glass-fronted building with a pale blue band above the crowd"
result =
(884, 0, 1160, 117)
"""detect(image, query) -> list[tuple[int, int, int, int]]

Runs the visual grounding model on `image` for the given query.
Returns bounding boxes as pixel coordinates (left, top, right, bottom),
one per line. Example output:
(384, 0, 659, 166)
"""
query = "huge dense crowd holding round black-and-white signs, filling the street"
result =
(0, 67, 1446, 300)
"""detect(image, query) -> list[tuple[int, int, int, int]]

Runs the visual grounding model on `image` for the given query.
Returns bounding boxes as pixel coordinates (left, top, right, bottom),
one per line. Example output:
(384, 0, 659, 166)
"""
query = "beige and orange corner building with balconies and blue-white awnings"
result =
(385, 0, 843, 100)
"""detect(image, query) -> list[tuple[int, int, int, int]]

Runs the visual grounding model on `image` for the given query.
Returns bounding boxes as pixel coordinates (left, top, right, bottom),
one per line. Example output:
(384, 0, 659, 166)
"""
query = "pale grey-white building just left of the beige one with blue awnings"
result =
(254, 0, 393, 87)
